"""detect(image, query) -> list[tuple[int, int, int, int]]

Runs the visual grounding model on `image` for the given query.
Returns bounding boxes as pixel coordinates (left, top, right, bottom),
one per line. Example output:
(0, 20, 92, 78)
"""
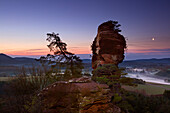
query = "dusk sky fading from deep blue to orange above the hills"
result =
(0, 0, 170, 60)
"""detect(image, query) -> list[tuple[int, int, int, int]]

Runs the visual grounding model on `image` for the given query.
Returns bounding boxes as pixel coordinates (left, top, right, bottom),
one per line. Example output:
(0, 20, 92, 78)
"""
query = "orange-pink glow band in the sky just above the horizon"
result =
(0, 46, 169, 56)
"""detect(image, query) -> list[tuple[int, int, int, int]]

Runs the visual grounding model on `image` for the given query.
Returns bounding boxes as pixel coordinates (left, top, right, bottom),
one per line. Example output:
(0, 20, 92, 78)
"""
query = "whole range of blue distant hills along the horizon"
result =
(0, 53, 170, 67)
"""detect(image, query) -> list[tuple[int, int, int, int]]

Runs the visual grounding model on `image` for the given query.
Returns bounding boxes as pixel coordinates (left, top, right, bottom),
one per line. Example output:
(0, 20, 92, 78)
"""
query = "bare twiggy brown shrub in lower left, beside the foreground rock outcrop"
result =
(2, 66, 57, 113)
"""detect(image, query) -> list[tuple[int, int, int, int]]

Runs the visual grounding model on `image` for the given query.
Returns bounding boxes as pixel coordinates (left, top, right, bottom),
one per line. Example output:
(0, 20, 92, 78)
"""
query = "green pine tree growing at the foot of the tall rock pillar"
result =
(92, 64, 136, 103)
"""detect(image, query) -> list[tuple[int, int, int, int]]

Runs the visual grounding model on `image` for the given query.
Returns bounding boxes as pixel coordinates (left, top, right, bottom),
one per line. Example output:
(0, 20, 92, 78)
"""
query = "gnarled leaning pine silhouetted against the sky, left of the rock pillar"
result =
(40, 33, 83, 77)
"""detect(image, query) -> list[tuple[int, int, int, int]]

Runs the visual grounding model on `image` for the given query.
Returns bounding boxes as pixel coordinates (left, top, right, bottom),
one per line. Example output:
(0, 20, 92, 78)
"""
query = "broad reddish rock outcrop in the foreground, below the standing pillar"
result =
(39, 77, 120, 113)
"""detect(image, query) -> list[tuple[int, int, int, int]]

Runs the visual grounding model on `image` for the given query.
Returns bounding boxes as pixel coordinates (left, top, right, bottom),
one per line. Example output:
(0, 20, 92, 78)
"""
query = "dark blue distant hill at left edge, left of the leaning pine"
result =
(0, 53, 37, 66)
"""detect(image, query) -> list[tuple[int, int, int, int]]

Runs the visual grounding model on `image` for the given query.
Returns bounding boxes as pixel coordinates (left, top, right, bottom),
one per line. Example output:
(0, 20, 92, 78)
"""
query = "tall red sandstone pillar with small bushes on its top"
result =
(92, 21, 126, 69)
